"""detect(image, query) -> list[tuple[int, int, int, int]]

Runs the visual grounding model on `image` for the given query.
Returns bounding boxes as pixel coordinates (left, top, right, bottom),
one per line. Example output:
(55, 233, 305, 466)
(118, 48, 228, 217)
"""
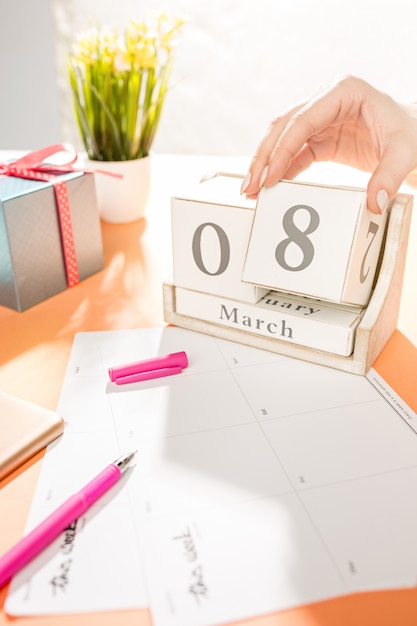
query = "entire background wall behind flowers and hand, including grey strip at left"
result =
(0, 0, 417, 155)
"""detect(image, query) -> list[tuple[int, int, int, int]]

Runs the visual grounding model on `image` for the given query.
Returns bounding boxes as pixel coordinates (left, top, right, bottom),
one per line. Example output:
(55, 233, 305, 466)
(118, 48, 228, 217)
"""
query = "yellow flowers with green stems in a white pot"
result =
(67, 13, 184, 221)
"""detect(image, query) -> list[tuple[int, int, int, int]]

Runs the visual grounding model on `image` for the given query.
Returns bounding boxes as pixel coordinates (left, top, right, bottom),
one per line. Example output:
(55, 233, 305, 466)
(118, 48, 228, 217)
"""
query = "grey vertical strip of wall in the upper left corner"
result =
(0, 0, 62, 149)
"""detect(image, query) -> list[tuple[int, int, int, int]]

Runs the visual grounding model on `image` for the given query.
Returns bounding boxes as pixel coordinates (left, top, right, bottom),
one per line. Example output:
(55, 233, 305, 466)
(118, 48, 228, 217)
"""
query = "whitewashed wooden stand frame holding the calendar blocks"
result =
(163, 194, 413, 375)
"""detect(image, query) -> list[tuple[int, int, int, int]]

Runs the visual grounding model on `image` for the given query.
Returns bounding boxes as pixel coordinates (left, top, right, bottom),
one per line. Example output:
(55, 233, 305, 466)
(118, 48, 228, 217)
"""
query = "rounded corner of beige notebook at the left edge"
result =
(0, 392, 64, 480)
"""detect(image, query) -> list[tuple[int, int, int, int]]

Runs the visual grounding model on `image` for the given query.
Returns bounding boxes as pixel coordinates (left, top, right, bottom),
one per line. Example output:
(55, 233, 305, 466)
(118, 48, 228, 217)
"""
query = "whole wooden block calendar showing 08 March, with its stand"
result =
(164, 174, 412, 374)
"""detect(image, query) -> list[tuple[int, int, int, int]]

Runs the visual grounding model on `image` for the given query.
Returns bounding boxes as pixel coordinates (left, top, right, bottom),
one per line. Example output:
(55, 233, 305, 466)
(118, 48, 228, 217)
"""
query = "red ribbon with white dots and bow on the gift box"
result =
(0, 143, 114, 287)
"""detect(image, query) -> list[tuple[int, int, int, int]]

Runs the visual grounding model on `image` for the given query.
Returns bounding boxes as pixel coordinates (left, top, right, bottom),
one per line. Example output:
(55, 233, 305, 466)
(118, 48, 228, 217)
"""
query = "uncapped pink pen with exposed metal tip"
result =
(0, 452, 136, 589)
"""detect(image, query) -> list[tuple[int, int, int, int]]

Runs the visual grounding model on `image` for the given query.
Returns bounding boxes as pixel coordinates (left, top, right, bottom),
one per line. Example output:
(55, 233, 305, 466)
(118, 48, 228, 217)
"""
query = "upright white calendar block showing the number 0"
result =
(171, 175, 268, 303)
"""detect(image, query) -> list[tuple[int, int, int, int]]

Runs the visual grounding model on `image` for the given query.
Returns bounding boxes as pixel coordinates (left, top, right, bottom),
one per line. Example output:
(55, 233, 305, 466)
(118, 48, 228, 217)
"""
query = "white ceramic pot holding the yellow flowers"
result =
(86, 156, 151, 223)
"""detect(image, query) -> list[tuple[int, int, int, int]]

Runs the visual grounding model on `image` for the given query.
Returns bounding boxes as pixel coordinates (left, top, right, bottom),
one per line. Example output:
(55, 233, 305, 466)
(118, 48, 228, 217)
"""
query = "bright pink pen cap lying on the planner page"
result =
(109, 351, 188, 385)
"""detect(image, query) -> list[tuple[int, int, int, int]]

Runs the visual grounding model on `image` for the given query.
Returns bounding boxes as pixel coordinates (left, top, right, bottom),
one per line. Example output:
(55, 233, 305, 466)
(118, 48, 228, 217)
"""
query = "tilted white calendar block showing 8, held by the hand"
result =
(242, 181, 387, 306)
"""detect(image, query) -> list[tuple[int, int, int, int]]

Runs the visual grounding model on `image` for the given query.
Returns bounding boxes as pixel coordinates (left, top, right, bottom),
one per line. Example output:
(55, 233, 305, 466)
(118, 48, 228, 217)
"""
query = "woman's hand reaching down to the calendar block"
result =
(241, 76, 417, 213)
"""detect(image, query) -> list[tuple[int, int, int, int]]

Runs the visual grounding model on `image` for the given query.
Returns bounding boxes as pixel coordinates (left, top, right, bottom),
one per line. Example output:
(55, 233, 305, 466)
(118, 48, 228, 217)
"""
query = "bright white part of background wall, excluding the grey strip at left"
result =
(53, 0, 417, 154)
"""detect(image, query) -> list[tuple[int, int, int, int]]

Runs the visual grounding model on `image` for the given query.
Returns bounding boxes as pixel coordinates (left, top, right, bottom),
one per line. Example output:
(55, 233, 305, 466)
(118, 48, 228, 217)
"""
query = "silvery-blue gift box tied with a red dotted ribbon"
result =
(0, 147, 103, 311)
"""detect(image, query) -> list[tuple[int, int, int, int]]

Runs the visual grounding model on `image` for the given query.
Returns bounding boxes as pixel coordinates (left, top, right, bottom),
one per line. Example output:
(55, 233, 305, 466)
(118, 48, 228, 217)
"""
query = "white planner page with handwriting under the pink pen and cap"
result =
(6, 327, 417, 626)
